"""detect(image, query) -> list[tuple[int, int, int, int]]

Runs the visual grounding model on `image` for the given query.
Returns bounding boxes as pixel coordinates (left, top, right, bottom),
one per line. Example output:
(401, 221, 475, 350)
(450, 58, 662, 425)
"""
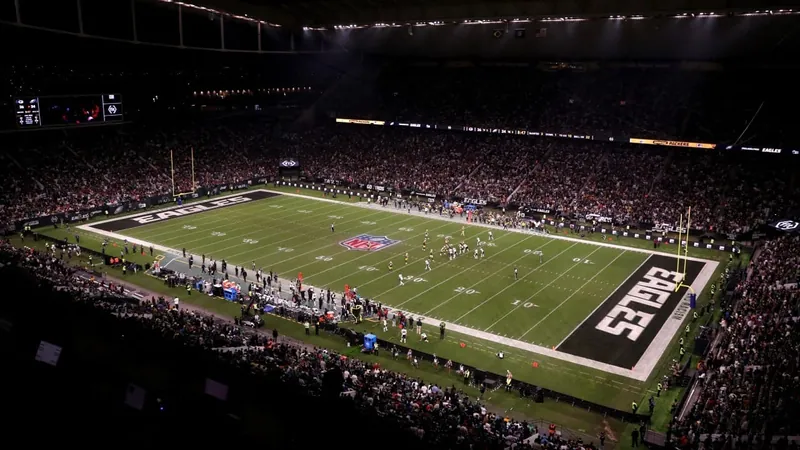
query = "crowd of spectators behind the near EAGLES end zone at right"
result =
(671, 236, 800, 448)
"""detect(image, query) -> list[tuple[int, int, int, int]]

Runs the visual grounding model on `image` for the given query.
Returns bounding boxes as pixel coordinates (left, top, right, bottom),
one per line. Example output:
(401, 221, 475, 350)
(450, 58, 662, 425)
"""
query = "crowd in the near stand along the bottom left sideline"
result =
(0, 242, 597, 450)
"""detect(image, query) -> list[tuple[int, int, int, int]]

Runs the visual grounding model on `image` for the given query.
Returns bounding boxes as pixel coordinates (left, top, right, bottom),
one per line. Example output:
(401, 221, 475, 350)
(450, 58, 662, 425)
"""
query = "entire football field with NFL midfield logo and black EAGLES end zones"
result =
(81, 190, 717, 410)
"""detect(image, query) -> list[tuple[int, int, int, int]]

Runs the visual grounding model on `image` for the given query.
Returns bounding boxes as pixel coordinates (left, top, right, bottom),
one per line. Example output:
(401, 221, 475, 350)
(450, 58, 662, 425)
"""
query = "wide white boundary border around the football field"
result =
(77, 189, 719, 381)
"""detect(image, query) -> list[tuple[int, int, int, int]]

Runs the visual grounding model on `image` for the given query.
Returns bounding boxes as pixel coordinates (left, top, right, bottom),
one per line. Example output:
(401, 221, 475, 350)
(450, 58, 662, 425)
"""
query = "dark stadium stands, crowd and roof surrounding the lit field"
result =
(0, 0, 800, 450)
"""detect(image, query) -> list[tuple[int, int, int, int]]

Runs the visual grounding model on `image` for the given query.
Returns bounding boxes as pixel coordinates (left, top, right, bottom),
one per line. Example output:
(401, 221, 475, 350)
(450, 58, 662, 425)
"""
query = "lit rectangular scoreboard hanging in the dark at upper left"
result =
(14, 94, 124, 129)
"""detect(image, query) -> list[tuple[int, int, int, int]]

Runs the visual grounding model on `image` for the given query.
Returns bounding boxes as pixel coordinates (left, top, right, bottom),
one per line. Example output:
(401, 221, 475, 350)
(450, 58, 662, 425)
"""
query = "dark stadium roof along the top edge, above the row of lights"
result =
(178, 0, 796, 27)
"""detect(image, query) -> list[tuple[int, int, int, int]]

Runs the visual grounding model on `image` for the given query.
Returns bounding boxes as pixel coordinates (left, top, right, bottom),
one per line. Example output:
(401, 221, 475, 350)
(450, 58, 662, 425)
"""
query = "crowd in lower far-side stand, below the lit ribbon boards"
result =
(2, 122, 800, 233)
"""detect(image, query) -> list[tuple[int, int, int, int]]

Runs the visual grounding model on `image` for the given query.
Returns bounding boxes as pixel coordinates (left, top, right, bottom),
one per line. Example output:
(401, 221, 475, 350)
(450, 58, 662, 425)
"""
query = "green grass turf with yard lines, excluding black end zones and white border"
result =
(57, 184, 720, 418)
